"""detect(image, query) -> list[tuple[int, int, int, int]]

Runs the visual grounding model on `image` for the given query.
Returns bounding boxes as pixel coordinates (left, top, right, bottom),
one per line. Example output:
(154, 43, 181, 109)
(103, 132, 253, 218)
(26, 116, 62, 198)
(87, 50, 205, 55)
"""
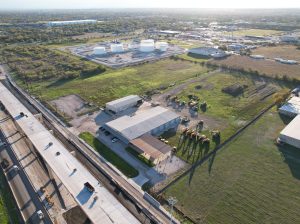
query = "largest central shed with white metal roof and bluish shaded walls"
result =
(104, 106, 180, 144)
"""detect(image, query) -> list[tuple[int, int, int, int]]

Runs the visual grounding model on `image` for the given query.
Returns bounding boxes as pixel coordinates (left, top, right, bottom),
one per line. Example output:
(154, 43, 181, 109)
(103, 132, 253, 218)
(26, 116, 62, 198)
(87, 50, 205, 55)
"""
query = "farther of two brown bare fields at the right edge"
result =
(252, 45, 300, 62)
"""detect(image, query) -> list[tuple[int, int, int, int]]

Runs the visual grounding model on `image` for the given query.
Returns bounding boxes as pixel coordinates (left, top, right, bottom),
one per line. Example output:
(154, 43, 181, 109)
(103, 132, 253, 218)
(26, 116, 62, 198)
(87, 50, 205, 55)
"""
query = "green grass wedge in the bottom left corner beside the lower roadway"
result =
(0, 170, 20, 224)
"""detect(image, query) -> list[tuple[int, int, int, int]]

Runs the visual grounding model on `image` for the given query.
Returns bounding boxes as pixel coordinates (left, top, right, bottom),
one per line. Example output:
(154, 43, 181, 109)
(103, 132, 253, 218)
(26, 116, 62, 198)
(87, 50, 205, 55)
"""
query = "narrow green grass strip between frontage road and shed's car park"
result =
(79, 132, 139, 178)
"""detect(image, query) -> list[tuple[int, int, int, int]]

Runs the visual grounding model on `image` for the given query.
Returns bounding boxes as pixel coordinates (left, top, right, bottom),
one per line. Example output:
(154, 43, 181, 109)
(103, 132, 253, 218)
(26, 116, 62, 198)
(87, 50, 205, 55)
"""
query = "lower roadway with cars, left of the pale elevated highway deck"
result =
(0, 130, 52, 224)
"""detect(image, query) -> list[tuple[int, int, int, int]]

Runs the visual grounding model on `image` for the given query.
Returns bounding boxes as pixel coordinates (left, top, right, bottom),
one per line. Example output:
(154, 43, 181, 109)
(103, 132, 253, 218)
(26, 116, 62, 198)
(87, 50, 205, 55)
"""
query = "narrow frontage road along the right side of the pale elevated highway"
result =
(1, 65, 179, 223)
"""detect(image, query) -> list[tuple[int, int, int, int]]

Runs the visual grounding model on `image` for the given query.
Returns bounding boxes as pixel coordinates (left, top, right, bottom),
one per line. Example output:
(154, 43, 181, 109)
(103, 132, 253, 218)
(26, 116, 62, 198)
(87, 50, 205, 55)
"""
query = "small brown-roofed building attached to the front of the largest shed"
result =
(129, 134, 172, 164)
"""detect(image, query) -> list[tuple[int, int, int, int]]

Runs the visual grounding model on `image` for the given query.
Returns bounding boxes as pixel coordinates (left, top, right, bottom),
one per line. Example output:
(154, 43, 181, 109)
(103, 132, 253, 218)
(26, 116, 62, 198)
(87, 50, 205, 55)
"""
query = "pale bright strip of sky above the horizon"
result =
(0, 0, 300, 10)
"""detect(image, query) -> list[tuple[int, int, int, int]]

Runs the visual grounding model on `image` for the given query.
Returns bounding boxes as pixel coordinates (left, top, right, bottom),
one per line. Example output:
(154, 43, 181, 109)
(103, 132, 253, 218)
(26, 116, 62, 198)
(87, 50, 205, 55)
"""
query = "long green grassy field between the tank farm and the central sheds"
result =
(24, 59, 208, 105)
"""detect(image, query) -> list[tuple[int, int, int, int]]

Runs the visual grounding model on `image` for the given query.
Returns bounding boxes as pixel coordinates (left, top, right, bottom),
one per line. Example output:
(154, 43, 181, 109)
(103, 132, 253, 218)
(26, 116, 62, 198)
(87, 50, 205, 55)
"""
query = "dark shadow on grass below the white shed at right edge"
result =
(277, 145, 300, 180)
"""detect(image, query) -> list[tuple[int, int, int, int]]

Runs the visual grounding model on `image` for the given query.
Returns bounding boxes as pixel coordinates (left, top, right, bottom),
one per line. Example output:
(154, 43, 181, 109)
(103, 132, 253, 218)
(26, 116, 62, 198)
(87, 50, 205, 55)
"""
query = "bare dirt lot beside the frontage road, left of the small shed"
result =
(50, 94, 93, 118)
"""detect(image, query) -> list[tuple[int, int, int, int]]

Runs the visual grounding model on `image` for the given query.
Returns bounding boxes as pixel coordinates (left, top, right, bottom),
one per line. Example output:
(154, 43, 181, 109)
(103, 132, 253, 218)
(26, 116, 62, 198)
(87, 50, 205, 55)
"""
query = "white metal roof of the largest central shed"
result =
(106, 106, 179, 141)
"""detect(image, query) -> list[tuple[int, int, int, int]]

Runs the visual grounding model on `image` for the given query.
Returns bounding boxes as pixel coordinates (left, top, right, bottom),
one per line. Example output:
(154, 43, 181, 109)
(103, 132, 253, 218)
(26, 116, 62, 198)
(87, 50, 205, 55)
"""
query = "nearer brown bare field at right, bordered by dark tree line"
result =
(210, 55, 300, 80)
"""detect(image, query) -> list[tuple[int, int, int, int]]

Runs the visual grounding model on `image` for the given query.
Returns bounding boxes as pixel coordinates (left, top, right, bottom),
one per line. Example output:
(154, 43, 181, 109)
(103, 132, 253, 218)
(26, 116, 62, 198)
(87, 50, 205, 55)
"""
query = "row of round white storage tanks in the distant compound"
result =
(93, 39, 169, 55)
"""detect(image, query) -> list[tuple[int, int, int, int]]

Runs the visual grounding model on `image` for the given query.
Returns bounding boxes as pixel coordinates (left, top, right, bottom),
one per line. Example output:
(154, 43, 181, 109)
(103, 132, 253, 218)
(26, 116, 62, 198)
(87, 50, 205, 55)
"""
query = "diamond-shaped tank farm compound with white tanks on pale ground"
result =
(68, 39, 185, 68)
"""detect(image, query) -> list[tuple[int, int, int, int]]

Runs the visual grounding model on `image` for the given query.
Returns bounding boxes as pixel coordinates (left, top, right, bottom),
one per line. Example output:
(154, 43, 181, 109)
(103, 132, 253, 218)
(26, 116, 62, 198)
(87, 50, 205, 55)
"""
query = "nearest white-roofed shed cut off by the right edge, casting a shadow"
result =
(279, 115, 300, 148)
